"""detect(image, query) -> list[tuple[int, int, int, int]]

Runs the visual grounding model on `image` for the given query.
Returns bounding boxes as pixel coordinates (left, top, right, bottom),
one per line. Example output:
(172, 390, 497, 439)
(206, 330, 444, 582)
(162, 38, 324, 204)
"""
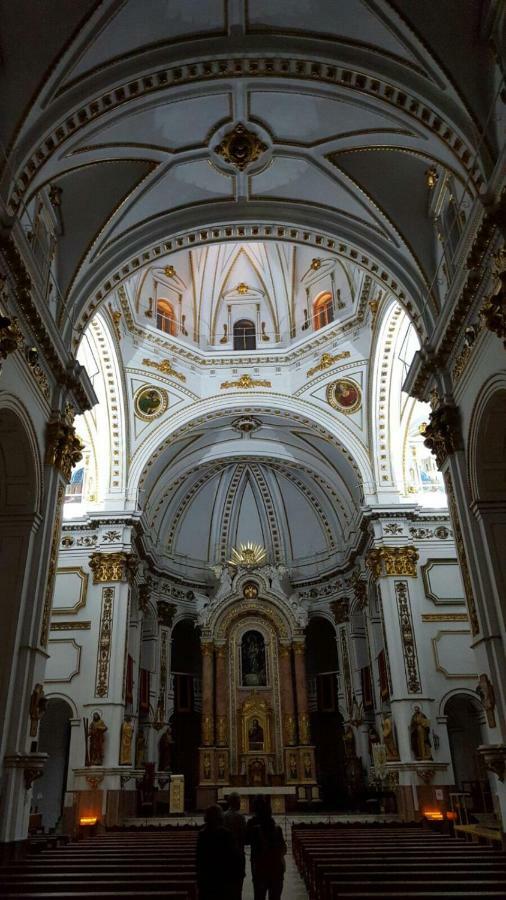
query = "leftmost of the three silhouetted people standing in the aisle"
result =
(197, 806, 243, 900)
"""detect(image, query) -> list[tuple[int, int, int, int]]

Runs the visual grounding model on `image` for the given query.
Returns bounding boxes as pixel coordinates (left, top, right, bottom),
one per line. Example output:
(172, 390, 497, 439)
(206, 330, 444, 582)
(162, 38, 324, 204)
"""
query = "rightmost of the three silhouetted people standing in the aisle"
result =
(246, 797, 286, 900)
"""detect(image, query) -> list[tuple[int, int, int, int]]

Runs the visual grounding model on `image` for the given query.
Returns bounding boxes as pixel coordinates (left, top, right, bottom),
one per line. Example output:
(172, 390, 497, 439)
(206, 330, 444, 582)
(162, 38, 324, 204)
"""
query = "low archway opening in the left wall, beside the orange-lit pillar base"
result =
(33, 697, 73, 830)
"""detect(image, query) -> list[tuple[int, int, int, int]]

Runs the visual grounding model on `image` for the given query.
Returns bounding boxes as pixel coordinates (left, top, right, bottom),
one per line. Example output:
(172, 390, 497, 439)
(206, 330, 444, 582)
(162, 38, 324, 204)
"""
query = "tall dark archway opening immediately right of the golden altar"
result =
(306, 616, 346, 809)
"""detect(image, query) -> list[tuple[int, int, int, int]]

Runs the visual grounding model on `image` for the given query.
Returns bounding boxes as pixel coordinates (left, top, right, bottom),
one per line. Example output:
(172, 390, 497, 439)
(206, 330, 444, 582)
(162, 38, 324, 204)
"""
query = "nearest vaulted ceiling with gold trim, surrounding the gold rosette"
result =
(0, 0, 504, 344)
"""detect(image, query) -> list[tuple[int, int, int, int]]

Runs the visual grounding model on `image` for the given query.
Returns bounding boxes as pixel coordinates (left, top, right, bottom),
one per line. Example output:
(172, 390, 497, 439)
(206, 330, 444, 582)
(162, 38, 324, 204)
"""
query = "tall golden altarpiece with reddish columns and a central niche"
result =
(197, 565, 319, 813)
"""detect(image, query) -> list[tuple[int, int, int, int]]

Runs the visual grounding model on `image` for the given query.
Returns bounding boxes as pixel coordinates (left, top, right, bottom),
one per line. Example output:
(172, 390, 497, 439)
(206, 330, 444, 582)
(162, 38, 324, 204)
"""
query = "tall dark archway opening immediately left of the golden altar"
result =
(170, 619, 202, 809)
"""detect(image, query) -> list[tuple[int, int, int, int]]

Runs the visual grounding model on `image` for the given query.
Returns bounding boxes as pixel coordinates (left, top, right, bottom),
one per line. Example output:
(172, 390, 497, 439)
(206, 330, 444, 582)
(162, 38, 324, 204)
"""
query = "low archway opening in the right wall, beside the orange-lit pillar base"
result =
(445, 694, 493, 813)
